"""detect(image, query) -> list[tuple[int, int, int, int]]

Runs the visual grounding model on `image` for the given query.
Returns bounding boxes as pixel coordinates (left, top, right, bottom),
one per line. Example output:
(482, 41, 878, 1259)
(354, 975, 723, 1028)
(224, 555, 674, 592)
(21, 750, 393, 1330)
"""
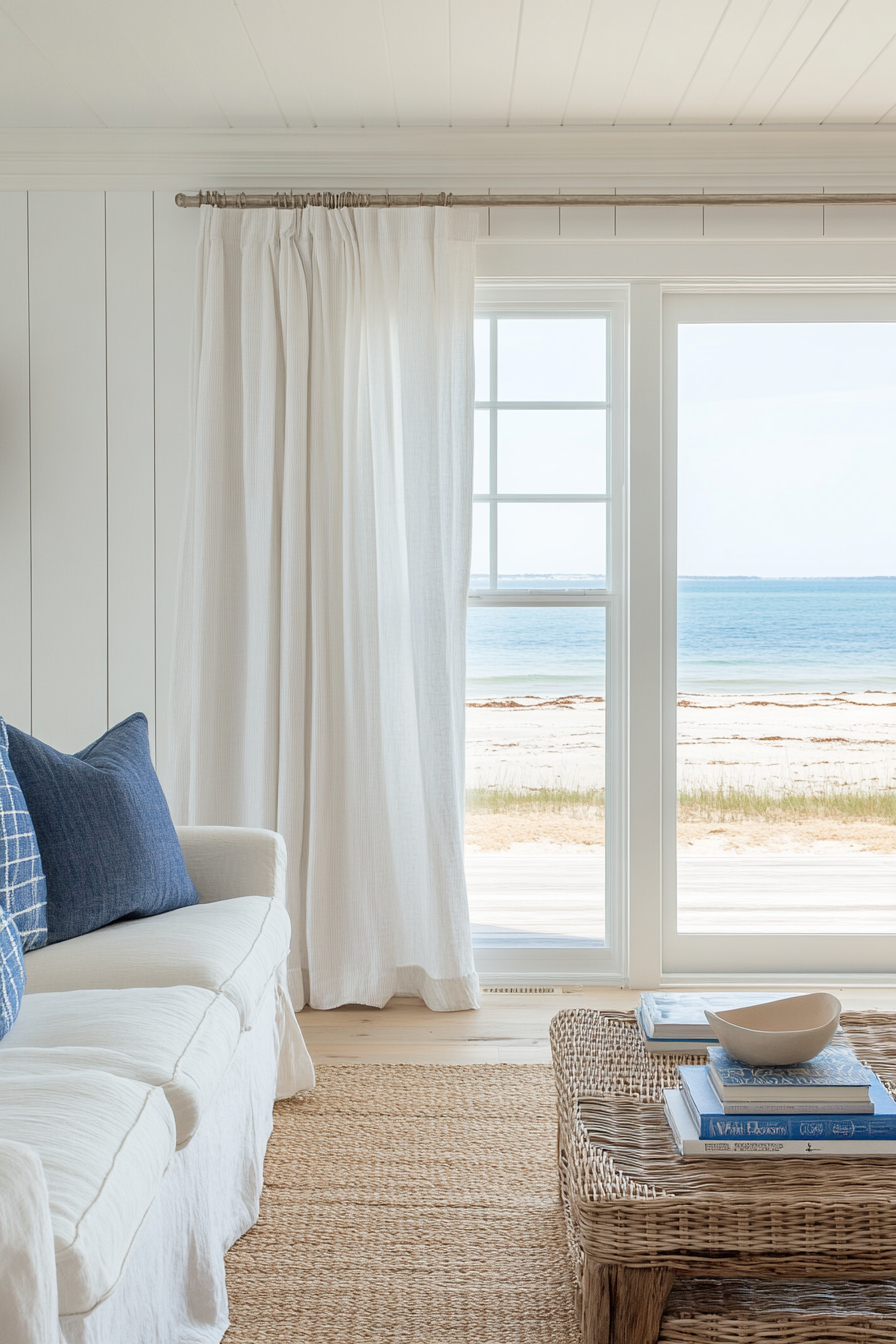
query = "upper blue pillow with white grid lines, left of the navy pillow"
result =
(0, 719, 47, 952)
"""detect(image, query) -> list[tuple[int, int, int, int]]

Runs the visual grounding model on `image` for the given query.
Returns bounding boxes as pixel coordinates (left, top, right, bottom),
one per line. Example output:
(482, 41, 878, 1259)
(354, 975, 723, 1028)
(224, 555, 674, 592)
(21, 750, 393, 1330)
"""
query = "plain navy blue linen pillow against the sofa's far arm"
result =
(8, 714, 199, 942)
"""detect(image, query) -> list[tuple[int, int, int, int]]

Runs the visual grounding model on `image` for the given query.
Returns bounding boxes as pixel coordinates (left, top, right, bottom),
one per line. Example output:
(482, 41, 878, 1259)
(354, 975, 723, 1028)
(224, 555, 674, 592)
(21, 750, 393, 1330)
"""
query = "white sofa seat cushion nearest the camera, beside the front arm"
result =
(0, 1071, 175, 1316)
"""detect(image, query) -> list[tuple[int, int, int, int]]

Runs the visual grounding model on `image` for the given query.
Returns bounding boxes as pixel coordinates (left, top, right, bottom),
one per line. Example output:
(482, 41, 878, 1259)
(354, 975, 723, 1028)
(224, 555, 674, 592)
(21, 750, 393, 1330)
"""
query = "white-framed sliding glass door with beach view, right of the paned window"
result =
(664, 296, 896, 978)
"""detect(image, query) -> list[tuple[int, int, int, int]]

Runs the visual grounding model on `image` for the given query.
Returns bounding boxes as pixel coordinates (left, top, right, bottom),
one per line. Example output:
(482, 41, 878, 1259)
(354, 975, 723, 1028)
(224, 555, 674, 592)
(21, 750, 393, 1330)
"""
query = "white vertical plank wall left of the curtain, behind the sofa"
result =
(0, 191, 199, 779)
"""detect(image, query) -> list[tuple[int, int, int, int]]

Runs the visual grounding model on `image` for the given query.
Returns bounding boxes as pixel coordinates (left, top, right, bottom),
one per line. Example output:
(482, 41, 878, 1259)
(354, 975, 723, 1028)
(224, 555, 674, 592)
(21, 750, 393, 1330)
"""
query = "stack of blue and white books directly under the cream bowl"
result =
(664, 1038, 896, 1157)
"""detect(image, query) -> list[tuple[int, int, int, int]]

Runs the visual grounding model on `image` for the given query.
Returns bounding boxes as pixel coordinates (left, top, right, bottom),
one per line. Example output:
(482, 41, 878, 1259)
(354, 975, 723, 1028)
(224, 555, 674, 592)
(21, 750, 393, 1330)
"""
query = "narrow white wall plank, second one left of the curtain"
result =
(106, 191, 156, 743)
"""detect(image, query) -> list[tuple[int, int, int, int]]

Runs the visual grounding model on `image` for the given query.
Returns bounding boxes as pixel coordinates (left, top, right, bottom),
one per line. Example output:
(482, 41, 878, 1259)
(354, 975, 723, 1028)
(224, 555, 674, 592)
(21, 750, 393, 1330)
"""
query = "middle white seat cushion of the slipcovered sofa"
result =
(0, 985, 240, 1148)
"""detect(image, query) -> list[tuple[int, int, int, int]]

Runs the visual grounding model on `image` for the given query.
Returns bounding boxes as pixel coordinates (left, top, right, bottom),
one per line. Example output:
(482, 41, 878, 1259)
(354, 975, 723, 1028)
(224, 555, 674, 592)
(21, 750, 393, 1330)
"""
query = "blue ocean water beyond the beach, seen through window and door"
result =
(467, 578, 896, 699)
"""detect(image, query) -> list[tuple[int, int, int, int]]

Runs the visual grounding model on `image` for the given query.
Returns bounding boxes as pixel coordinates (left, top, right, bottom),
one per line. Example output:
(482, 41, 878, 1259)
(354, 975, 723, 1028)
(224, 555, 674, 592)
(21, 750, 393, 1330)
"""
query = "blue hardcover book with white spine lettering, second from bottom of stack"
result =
(678, 1064, 896, 1140)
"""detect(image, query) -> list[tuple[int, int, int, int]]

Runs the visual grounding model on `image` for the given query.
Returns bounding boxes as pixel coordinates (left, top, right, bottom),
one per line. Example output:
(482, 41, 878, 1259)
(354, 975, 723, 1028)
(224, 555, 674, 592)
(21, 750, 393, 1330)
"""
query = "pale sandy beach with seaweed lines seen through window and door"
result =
(466, 691, 896, 855)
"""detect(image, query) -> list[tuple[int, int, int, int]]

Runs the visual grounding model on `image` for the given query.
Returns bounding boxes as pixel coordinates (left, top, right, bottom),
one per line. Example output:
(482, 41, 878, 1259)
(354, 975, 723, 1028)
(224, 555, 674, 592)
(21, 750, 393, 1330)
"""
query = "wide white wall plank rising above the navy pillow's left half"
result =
(28, 191, 107, 751)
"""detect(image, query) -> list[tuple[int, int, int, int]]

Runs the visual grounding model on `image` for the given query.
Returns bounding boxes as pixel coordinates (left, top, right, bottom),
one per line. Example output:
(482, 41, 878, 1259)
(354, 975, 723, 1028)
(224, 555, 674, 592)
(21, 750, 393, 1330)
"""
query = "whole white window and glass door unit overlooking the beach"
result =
(466, 277, 896, 988)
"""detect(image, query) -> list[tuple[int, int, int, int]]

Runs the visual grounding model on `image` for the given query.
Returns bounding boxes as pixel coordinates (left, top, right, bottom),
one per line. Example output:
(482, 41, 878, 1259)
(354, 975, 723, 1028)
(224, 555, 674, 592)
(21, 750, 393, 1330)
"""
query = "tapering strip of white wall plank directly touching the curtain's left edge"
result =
(153, 191, 199, 790)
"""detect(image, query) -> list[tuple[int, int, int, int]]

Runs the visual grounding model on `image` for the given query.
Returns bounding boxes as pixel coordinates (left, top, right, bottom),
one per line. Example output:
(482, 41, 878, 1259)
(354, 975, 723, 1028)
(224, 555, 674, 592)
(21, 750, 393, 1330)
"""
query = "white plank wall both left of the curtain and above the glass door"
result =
(0, 181, 896, 806)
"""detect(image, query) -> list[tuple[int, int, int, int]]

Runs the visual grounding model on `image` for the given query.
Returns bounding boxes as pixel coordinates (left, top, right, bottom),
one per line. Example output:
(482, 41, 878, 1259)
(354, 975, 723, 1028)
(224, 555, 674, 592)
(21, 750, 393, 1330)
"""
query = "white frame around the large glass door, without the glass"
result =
(663, 294, 896, 985)
